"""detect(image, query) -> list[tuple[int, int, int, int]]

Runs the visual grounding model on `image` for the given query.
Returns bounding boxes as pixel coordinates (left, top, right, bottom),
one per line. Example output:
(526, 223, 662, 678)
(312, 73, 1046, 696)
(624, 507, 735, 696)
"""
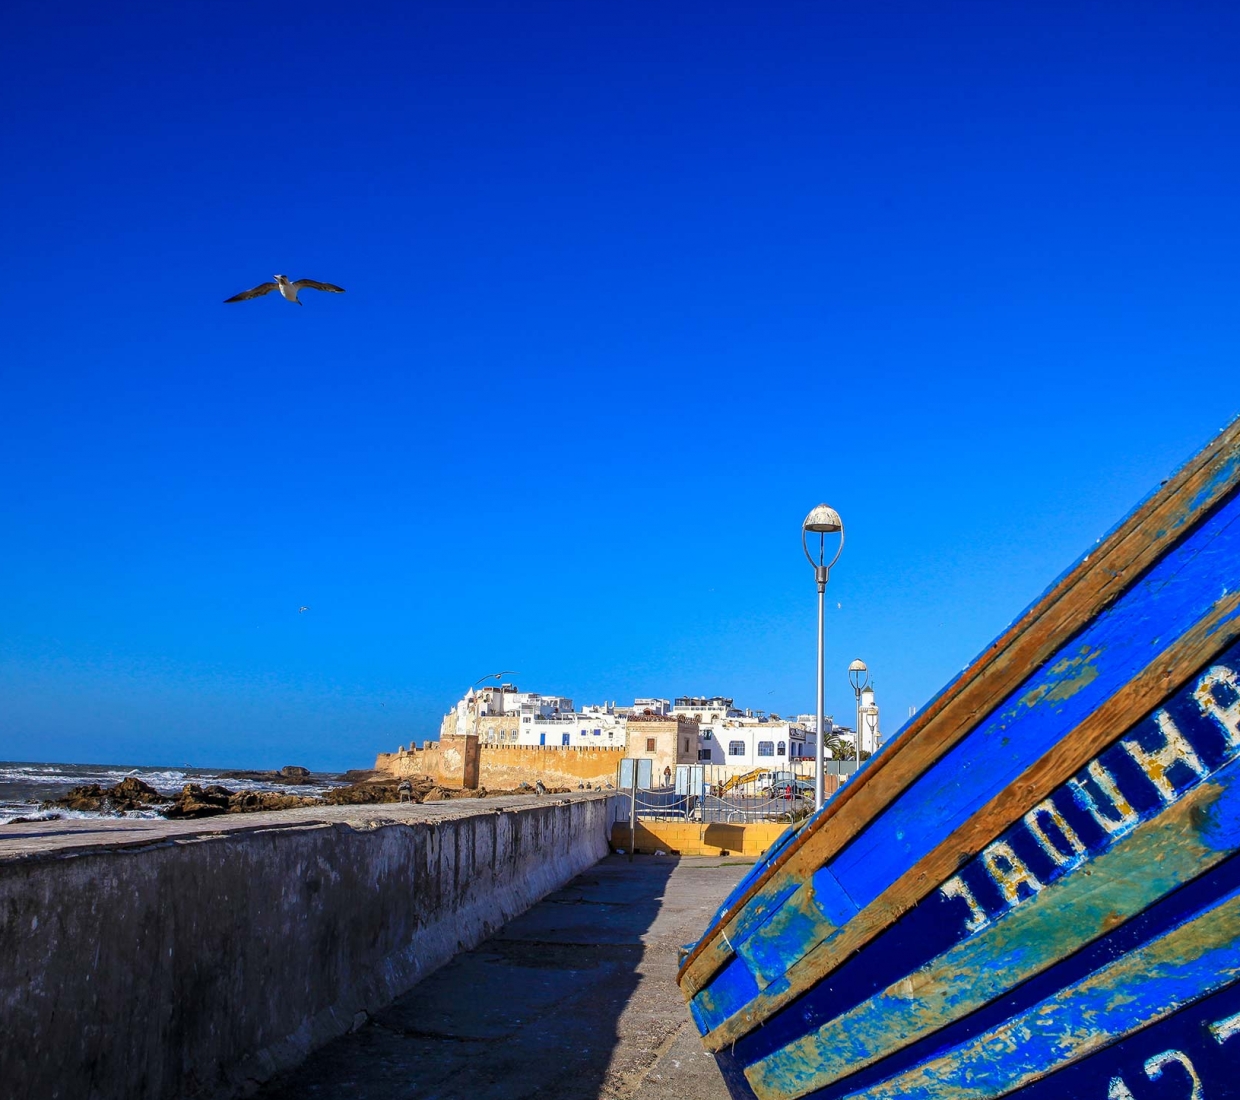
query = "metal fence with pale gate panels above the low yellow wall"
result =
(615, 759, 852, 825)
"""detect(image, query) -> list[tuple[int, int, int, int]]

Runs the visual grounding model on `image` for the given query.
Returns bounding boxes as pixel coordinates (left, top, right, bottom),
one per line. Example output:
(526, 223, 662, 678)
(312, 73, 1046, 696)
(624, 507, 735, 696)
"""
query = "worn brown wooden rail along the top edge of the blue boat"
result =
(677, 418, 1240, 1000)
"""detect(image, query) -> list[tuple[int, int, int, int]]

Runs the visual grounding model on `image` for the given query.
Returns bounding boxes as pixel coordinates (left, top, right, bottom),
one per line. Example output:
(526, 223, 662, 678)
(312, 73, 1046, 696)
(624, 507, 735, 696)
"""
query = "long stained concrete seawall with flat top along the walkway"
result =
(0, 796, 611, 1100)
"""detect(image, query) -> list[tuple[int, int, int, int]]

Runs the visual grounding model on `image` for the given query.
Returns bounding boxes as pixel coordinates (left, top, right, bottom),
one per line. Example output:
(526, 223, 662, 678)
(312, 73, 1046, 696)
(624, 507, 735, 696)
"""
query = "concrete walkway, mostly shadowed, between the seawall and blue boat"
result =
(258, 856, 748, 1100)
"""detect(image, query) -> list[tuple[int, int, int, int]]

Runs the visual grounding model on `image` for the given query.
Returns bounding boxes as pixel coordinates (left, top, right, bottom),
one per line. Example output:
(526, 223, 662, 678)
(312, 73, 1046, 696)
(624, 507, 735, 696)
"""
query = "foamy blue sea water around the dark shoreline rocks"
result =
(0, 761, 346, 825)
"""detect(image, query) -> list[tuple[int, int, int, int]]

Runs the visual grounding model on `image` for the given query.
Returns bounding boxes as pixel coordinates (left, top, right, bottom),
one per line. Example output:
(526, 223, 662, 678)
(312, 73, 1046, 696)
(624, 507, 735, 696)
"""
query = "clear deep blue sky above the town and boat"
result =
(0, 0, 1240, 768)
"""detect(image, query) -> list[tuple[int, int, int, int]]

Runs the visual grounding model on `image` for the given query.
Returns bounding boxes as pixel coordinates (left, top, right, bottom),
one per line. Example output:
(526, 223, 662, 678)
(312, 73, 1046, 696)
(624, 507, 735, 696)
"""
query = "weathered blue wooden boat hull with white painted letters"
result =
(681, 424, 1240, 1100)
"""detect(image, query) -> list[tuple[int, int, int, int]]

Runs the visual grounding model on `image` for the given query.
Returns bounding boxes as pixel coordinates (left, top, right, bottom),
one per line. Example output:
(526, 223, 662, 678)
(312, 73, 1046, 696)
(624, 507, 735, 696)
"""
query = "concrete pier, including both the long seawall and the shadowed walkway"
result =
(0, 794, 748, 1100)
